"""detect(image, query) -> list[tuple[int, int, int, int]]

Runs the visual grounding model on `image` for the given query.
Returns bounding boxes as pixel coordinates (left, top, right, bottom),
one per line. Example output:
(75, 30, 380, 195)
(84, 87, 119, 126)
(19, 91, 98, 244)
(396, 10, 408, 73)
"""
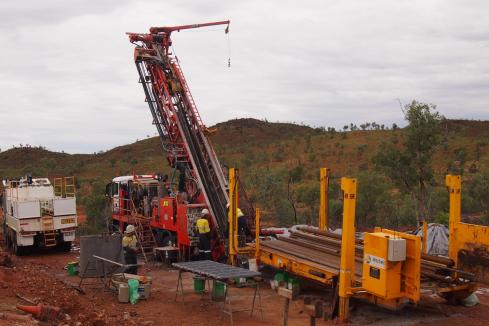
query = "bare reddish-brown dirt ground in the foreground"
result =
(0, 248, 489, 326)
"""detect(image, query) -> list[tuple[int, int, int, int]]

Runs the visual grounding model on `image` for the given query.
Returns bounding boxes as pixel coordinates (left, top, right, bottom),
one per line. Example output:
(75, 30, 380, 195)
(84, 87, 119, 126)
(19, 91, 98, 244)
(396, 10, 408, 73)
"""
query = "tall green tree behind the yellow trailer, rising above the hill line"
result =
(374, 101, 443, 224)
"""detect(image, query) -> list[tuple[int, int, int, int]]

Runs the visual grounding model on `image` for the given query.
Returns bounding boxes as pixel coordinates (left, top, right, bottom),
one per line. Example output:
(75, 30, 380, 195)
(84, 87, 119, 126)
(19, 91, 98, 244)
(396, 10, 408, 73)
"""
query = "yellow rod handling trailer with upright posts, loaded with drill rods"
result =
(255, 172, 480, 321)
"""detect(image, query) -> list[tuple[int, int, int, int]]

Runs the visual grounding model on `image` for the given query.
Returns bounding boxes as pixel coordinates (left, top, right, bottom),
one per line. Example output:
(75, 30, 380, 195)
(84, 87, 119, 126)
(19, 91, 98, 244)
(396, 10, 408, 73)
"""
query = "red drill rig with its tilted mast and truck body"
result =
(116, 21, 246, 258)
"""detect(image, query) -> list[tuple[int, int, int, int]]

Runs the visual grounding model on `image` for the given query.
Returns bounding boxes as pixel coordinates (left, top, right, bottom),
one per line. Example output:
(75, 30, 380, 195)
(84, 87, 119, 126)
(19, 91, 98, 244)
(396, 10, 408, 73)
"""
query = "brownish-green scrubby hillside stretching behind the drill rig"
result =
(0, 119, 489, 228)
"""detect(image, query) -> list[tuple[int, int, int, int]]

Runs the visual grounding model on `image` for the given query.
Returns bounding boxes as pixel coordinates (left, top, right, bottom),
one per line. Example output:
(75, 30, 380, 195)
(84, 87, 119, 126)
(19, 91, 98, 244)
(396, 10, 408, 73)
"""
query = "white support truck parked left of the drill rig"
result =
(2, 176, 78, 255)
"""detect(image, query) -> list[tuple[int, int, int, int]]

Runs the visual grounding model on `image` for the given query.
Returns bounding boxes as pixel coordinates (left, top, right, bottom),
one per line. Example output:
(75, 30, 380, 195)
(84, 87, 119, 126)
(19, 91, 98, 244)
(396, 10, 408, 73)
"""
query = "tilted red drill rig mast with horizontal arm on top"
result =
(127, 21, 233, 251)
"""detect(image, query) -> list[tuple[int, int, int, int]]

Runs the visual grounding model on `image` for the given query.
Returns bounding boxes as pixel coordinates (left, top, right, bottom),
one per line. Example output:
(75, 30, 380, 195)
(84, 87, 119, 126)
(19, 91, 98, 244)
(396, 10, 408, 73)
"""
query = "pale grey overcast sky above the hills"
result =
(0, 0, 489, 153)
